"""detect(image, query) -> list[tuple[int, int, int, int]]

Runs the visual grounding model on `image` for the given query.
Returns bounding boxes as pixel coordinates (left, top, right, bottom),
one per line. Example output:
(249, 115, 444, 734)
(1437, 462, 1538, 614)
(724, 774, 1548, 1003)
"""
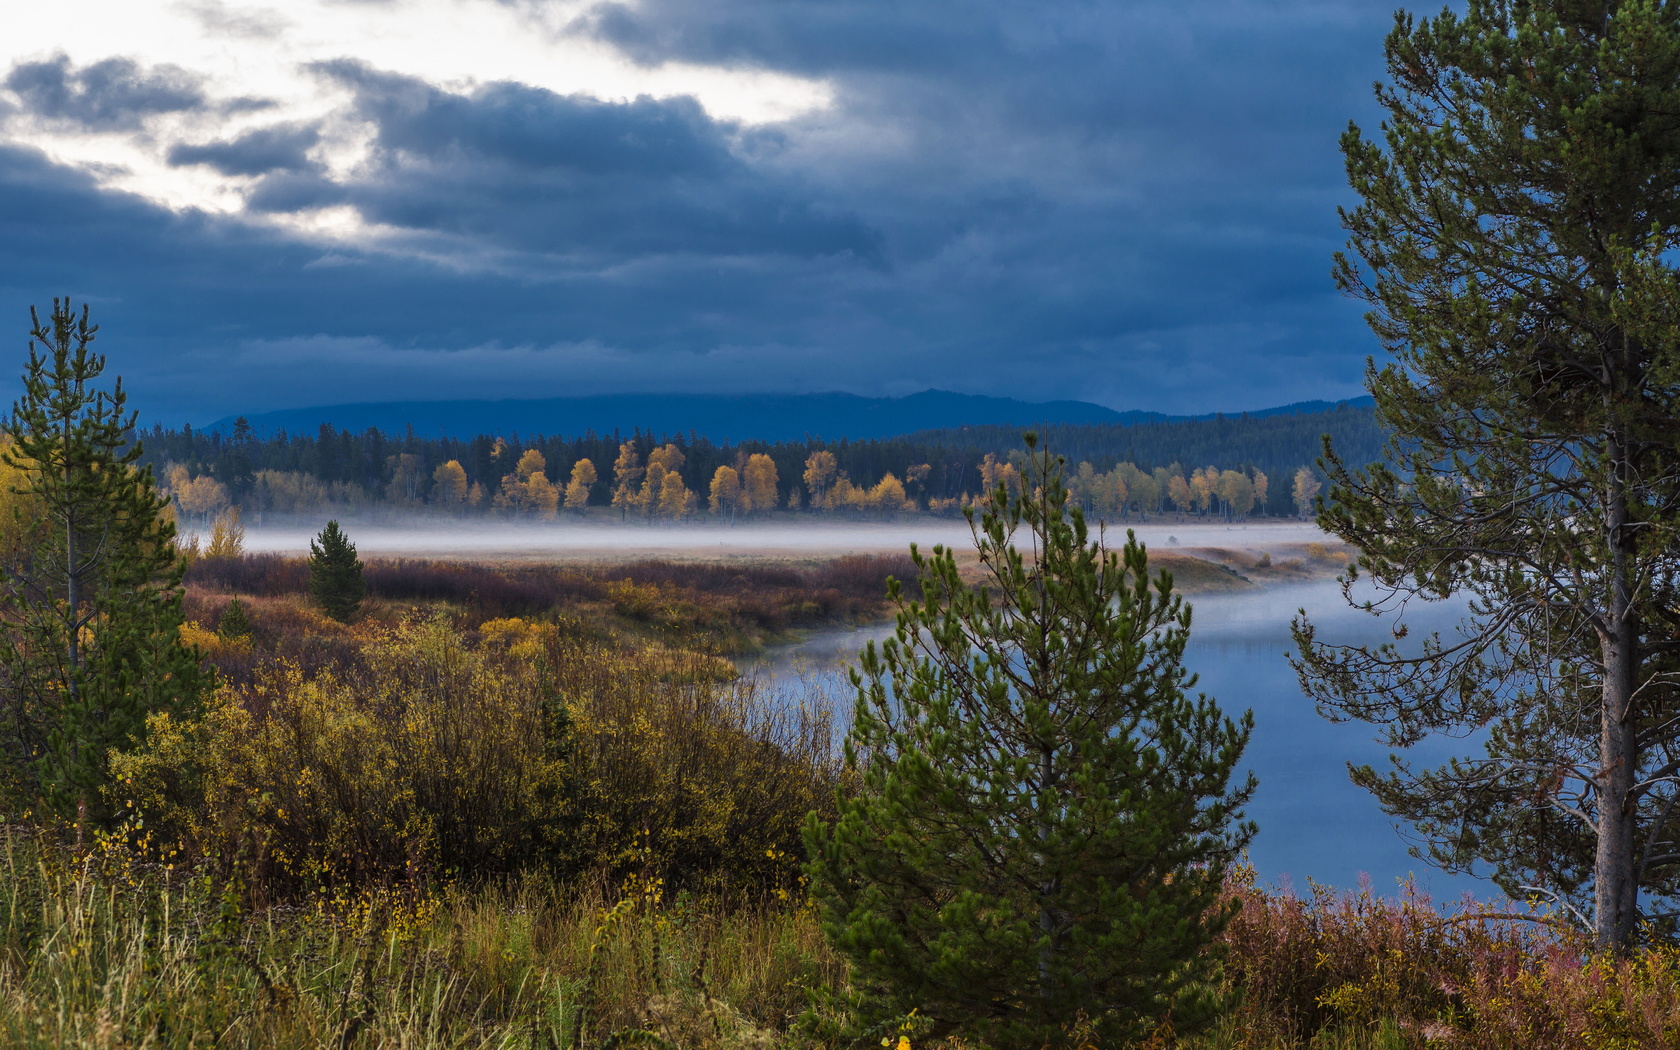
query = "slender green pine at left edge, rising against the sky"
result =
(0, 299, 203, 822)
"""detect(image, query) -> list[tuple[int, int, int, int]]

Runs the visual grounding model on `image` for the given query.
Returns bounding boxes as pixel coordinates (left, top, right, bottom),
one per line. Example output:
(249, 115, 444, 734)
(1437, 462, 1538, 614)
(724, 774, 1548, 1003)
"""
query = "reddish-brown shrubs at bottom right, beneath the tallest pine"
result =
(1223, 872, 1680, 1050)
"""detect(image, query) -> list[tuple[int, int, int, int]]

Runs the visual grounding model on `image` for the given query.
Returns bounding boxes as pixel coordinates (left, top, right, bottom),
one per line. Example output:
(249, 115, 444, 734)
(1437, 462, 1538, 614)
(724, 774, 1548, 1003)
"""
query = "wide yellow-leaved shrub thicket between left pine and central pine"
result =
(114, 618, 838, 894)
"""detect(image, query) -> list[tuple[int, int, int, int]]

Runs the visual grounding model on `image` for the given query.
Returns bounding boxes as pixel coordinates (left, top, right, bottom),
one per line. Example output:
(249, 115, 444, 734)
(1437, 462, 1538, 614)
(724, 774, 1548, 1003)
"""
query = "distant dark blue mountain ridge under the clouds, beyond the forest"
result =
(205, 390, 1371, 444)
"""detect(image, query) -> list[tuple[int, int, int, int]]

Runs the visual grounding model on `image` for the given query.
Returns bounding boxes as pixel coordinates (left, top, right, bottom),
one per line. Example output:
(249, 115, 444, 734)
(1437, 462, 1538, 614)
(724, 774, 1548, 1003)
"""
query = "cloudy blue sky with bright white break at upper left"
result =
(0, 0, 1393, 423)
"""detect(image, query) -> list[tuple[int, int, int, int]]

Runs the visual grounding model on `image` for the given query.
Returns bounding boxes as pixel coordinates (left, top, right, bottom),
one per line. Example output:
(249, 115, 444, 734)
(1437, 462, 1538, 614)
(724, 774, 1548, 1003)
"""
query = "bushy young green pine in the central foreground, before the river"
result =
(806, 435, 1253, 1048)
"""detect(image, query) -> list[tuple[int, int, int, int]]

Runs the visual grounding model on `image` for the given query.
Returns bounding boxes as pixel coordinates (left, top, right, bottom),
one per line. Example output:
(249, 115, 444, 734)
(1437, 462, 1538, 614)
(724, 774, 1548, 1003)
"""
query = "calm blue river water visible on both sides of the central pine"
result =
(744, 583, 1494, 899)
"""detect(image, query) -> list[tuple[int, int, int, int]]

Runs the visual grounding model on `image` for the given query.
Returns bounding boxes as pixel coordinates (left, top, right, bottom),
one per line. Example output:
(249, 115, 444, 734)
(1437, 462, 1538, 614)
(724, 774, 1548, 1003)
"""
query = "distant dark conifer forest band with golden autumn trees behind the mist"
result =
(139, 396, 1381, 522)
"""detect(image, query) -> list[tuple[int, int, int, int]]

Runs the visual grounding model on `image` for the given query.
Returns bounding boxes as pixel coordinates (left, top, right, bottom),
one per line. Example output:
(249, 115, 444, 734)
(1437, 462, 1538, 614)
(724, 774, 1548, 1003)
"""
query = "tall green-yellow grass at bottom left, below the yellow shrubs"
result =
(0, 828, 840, 1048)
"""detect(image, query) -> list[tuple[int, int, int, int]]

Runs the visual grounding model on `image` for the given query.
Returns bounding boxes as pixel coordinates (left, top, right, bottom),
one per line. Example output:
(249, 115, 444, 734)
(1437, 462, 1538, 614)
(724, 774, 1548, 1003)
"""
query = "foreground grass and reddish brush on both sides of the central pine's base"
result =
(0, 825, 1680, 1050)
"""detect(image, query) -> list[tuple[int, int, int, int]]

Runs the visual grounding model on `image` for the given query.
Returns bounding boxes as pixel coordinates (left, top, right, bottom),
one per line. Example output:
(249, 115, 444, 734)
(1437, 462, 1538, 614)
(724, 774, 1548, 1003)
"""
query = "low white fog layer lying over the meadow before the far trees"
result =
(245, 517, 1327, 559)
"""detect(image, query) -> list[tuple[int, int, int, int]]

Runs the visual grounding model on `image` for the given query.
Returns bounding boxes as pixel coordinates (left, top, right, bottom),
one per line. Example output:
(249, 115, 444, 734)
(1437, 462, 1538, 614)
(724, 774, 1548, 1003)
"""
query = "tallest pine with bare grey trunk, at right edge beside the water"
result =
(1299, 0, 1680, 948)
